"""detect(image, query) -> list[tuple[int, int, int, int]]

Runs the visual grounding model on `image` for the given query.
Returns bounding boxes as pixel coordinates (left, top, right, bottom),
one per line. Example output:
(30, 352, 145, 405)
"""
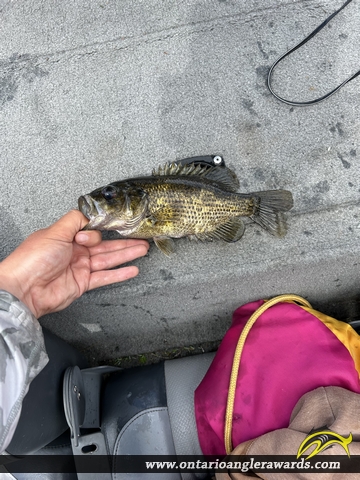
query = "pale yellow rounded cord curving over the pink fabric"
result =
(224, 294, 312, 455)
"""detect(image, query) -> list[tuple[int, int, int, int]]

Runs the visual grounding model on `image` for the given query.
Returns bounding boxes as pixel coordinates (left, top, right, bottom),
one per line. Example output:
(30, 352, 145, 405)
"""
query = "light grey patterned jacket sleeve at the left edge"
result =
(0, 290, 48, 452)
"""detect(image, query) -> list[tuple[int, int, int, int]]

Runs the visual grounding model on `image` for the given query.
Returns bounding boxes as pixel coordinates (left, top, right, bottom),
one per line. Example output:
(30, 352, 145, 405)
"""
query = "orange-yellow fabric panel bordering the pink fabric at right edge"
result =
(303, 307, 360, 374)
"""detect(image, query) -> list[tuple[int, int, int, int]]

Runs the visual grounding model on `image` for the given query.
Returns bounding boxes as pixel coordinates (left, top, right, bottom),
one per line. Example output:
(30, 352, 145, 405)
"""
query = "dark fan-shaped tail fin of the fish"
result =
(251, 190, 294, 237)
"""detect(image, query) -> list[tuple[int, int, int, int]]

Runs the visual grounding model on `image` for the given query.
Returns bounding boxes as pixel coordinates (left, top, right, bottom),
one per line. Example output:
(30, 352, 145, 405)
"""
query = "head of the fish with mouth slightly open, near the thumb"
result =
(78, 182, 148, 233)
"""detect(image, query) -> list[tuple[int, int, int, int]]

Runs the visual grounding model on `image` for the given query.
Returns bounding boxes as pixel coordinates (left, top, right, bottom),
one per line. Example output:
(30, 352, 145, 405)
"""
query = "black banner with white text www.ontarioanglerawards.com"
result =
(0, 454, 360, 474)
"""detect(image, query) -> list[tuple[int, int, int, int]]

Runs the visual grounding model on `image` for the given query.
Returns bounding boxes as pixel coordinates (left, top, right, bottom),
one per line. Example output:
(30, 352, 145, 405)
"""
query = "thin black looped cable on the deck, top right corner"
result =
(267, 0, 360, 107)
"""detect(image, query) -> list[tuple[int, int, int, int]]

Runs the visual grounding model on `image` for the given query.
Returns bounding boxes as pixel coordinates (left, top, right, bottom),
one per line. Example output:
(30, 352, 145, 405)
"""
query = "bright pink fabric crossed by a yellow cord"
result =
(195, 300, 360, 455)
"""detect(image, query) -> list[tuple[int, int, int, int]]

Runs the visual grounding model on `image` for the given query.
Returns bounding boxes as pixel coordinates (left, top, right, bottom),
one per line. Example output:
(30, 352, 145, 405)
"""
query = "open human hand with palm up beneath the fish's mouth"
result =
(0, 210, 149, 318)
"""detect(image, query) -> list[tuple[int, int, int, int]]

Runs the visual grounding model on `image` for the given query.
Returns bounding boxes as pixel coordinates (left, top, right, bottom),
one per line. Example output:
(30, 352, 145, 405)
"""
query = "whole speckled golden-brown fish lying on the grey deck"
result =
(78, 162, 293, 256)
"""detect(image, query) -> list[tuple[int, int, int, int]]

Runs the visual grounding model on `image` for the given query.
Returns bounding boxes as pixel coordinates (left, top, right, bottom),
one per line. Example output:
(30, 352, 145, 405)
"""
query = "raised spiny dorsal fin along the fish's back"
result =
(152, 162, 240, 192)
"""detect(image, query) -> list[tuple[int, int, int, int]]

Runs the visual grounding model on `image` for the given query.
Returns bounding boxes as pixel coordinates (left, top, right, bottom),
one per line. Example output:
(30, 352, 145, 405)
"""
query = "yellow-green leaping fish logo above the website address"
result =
(296, 429, 352, 460)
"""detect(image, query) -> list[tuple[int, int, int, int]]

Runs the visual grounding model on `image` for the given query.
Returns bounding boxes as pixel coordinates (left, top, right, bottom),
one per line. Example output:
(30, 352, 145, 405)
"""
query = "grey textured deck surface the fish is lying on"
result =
(0, 0, 360, 359)
